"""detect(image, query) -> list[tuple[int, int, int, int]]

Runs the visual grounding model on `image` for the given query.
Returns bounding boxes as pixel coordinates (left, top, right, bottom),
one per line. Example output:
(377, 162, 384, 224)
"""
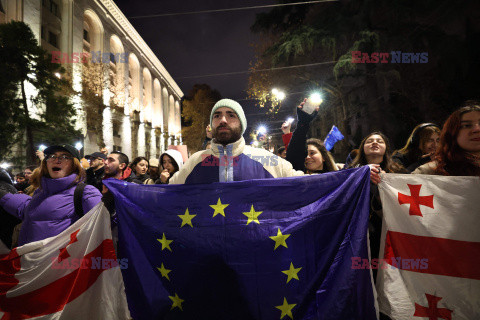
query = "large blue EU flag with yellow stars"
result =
(104, 167, 376, 320)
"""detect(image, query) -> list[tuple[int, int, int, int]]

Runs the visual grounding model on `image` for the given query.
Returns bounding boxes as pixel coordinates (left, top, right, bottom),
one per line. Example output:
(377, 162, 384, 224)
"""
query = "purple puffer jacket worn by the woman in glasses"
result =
(0, 174, 102, 246)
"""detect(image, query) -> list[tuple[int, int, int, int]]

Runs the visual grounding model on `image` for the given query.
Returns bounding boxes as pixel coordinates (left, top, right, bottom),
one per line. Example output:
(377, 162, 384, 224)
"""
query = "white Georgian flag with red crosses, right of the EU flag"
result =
(377, 174, 480, 320)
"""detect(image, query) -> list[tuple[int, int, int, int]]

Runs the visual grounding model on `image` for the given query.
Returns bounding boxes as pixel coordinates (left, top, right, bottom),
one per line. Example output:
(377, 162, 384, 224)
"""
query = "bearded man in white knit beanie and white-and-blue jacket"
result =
(169, 99, 303, 184)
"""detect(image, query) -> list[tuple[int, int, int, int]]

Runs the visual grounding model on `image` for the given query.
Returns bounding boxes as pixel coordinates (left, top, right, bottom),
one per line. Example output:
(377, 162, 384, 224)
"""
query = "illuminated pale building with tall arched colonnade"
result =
(0, 0, 183, 158)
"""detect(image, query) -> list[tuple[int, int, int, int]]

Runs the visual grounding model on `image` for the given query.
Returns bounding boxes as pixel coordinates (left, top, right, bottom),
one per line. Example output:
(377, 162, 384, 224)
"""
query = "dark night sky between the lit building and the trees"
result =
(115, 0, 292, 140)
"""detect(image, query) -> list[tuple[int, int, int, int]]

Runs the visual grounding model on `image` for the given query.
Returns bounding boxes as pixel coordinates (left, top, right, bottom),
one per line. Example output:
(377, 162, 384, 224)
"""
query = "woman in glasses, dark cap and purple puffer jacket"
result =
(0, 144, 102, 246)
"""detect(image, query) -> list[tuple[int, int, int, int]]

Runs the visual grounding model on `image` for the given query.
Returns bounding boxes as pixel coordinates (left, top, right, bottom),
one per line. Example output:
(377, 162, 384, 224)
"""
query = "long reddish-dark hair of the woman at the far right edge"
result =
(435, 101, 480, 176)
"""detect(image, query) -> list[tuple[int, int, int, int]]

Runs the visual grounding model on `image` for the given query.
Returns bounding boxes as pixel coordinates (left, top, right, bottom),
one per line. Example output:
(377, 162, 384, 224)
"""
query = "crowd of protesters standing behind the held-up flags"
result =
(0, 99, 480, 251)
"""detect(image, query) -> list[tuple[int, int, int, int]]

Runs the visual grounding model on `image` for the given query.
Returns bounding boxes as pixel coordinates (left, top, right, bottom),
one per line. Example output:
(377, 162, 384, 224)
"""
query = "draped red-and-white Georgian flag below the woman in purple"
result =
(0, 203, 130, 320)
